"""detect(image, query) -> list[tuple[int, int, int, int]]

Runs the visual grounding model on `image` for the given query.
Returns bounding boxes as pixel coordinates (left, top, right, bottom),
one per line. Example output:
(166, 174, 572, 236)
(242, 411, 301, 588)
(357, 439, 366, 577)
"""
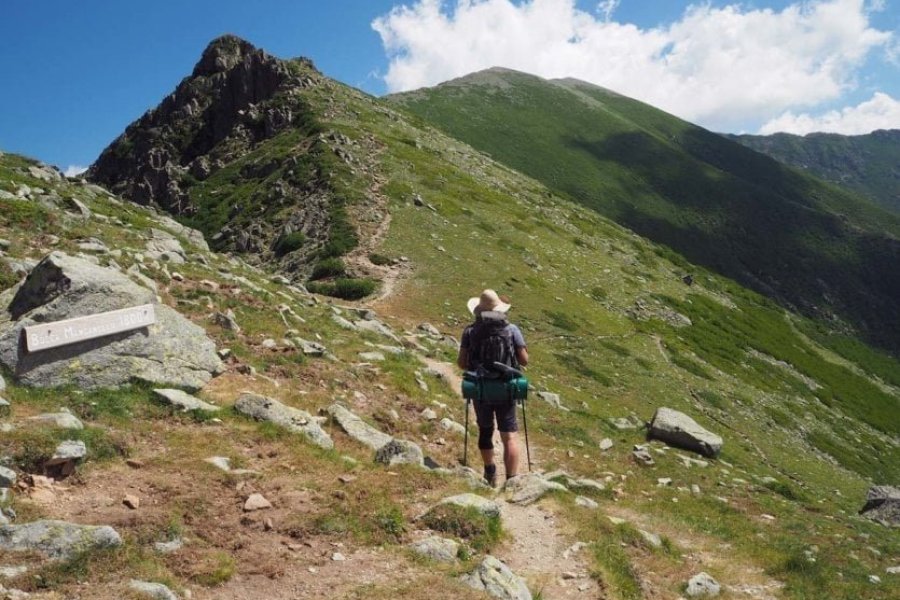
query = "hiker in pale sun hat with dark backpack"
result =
(456, 290, 528, 487)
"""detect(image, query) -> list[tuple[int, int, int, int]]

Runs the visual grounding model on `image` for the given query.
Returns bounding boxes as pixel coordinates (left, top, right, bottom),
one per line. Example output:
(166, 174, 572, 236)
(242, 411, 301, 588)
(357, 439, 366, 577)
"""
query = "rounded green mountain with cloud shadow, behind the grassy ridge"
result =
(389, 69, 900, 352)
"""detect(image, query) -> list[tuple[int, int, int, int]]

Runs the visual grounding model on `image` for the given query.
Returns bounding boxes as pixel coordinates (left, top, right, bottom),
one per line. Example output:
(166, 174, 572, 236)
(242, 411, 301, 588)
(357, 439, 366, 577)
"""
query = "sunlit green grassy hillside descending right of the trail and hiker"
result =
(298, 77, 900, 598)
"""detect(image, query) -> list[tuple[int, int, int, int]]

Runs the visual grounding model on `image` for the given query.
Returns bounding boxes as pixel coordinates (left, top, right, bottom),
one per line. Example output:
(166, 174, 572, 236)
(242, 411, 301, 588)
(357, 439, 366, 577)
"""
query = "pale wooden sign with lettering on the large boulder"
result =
(25, 304, 156, 352)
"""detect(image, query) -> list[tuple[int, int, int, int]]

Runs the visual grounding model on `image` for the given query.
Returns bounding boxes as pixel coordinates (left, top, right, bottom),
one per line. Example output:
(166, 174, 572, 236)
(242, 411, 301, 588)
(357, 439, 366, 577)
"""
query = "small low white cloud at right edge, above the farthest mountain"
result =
(759, 92, 900, 135)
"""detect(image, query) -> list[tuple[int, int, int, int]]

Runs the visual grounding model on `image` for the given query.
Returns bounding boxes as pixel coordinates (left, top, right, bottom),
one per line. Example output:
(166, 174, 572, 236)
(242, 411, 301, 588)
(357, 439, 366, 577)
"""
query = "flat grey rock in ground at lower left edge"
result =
(0, 520, 122, 559)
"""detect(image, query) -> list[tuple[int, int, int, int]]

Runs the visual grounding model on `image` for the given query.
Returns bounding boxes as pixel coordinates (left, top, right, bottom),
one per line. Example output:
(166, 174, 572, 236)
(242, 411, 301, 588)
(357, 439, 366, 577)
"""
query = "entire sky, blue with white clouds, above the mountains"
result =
(0, 0, 900, 168)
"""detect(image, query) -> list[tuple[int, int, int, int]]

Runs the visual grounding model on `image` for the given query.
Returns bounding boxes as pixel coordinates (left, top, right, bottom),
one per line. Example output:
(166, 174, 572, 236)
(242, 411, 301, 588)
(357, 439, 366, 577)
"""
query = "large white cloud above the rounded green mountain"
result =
(372, 0, 892, 131)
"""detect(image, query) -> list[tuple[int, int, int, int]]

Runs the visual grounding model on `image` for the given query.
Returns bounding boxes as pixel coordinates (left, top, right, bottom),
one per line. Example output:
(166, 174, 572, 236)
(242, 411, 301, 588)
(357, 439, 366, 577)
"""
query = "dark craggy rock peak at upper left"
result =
(86, 35, 338, 274)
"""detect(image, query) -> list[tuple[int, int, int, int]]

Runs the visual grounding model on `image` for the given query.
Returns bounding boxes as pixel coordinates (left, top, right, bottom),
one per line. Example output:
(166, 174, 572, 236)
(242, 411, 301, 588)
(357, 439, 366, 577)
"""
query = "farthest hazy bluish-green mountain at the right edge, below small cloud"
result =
(727, 129, 900, 213)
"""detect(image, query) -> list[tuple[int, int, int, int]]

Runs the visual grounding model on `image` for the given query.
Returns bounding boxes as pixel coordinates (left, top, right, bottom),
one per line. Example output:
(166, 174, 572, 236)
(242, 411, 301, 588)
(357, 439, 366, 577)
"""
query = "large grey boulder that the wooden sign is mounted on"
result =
(0, 252, 222, 389)
